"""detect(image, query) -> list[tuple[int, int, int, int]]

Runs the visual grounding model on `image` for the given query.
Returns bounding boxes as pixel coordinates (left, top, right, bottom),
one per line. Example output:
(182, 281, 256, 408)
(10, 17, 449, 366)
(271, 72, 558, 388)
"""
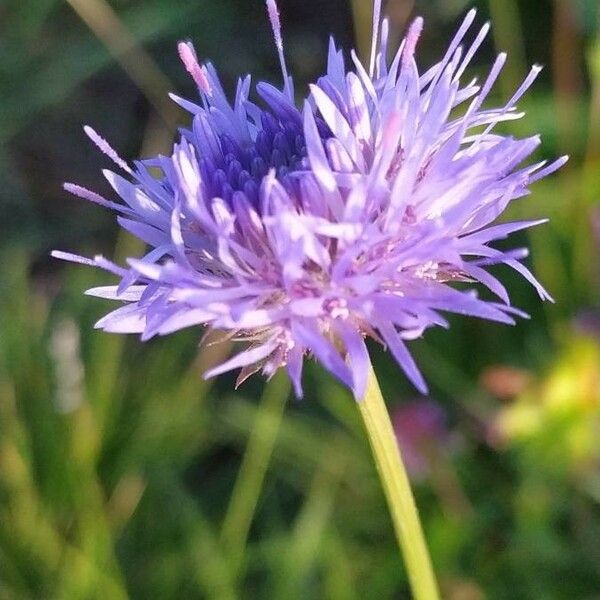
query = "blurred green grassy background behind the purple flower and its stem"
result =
(0, 0, 600, 600)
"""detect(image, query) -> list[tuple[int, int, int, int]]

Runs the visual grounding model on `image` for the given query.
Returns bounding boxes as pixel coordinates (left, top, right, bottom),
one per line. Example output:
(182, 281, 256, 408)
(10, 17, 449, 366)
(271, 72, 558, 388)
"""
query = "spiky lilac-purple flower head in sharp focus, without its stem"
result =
(54, 0, 566, 399)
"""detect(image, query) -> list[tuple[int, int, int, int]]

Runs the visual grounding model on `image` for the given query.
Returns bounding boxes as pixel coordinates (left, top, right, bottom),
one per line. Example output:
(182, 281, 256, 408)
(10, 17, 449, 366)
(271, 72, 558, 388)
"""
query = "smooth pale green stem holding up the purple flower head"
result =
(357, 368, 439, 600)
